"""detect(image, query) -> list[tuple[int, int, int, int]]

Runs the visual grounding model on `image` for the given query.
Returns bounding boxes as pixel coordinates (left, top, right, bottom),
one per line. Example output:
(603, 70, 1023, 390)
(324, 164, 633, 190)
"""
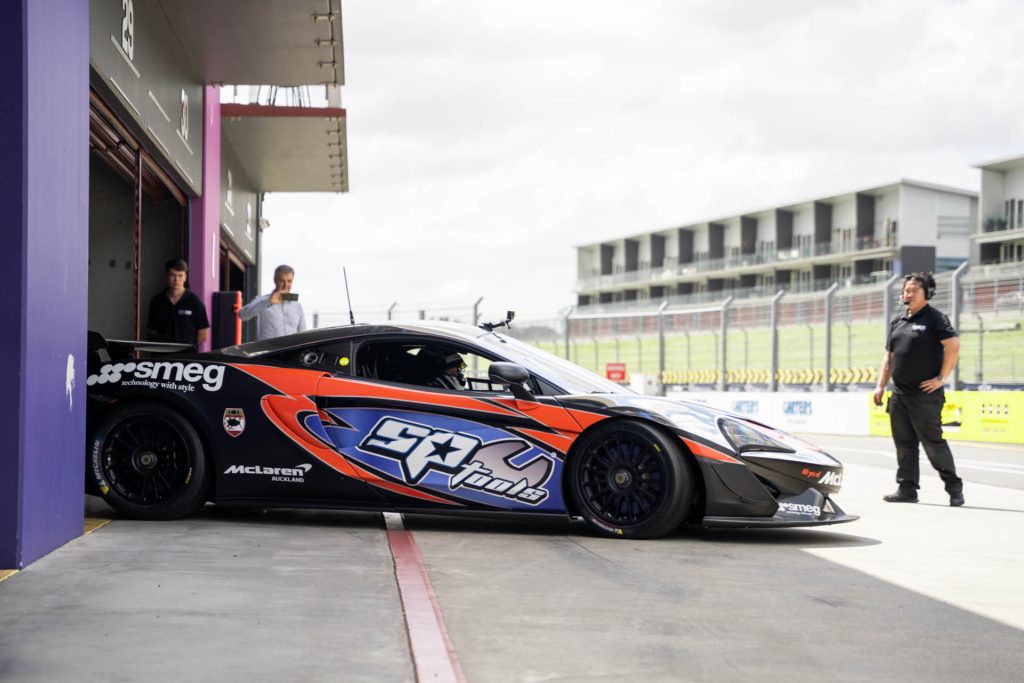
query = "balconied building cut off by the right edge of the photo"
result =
(971, 157, 1024, 268)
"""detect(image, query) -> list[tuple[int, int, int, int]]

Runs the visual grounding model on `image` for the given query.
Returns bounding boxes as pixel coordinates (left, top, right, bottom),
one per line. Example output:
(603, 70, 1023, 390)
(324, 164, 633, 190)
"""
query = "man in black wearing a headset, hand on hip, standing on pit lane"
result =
(874, 272, 964, 507)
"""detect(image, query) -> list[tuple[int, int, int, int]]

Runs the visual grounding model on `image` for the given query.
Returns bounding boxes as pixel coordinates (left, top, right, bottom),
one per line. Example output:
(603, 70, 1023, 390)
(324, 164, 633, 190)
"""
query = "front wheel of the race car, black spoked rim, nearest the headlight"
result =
(569, 421, 694, 539)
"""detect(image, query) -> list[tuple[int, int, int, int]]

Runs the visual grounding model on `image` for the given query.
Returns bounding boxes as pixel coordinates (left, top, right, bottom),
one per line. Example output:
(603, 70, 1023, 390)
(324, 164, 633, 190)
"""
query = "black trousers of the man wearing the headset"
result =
(889, 391, 964, 494)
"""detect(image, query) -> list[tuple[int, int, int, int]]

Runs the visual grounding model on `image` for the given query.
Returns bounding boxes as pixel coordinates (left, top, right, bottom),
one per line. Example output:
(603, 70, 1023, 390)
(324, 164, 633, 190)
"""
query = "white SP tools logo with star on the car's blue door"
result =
(358, 418, 553, 505)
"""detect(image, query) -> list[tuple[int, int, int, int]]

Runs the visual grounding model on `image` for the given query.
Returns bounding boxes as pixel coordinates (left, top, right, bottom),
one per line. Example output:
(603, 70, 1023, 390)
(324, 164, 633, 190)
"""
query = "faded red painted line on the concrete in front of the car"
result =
(384, 513, 466, 683)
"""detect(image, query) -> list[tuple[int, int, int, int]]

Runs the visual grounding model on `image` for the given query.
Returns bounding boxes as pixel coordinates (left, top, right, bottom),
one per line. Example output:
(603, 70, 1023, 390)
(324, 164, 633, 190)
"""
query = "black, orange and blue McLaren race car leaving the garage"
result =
(86, 322, 856, 539)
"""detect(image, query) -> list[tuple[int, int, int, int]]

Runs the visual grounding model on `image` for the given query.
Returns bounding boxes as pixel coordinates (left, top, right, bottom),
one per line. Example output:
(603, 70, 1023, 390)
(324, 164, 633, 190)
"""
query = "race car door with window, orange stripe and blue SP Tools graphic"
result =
(316, 336, 574, 513)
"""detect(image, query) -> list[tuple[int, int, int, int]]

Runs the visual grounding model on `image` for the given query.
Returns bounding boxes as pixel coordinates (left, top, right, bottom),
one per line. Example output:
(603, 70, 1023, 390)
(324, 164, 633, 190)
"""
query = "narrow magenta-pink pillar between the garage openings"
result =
(188, 85, 220, 351)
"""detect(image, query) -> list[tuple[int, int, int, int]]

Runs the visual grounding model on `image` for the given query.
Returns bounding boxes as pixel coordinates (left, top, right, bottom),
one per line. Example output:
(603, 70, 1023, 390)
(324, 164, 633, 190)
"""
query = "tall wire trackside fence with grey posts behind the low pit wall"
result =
(503, 264, 1024, 391)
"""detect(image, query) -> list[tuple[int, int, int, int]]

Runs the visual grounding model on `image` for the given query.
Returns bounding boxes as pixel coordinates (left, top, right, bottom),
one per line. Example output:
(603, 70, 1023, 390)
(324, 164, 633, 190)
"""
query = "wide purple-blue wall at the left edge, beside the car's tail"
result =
(0, 0, 89, 568)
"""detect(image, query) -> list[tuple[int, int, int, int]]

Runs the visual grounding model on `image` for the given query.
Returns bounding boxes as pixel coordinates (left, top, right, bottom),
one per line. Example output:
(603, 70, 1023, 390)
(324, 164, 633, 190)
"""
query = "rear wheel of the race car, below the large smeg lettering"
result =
(87, 402, 207, 519)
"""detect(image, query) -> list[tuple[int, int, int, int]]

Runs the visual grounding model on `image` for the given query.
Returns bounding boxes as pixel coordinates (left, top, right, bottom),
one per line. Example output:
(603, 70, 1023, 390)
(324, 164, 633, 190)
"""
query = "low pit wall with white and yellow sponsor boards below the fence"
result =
(666, 388, 1024, 444)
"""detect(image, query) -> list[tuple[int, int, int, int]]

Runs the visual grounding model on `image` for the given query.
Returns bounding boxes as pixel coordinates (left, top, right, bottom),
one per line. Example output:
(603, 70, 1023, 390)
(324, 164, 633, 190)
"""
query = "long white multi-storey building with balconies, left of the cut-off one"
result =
(577, 180, 974, 310)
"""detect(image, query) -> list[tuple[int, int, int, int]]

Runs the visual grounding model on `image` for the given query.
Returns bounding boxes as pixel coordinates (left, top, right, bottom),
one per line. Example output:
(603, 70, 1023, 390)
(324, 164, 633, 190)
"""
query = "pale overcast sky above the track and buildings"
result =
(261, 0, 1024, 325)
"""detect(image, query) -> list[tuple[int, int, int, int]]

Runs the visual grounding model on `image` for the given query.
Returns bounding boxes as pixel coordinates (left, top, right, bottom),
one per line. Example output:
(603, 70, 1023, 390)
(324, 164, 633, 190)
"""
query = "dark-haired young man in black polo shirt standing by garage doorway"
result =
(145, 259, 210, 346)
